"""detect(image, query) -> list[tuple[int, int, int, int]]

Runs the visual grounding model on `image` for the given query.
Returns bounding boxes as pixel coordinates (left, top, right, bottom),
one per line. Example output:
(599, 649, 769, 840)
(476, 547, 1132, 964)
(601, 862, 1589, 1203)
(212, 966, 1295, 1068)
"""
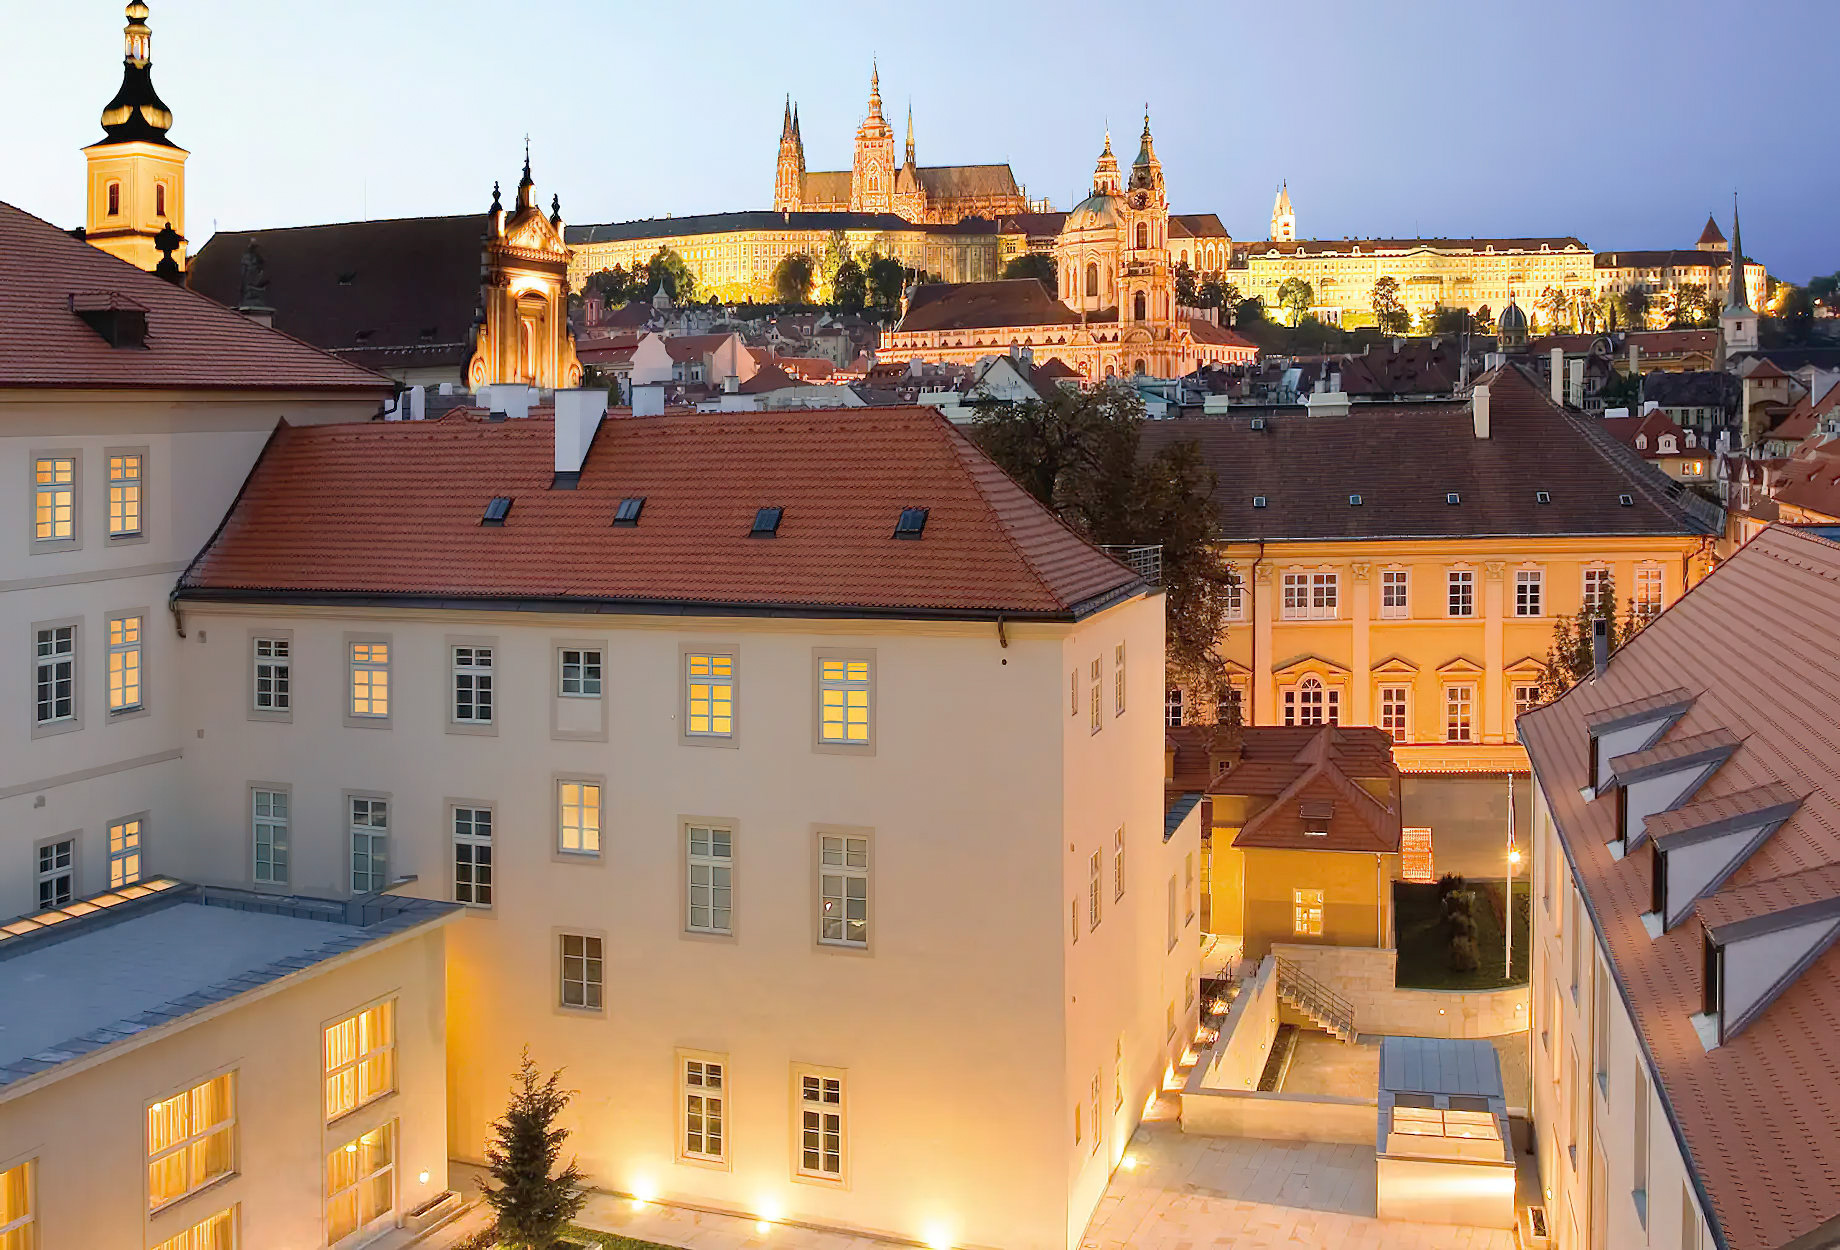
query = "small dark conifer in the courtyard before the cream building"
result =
(480, 1047, 587, 1250)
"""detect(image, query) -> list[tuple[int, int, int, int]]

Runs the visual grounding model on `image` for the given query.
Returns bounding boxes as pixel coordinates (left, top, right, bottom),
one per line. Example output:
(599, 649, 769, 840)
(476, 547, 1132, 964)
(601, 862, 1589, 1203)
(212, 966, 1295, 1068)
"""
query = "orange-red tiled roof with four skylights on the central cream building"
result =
(178, 407, 1143, 619)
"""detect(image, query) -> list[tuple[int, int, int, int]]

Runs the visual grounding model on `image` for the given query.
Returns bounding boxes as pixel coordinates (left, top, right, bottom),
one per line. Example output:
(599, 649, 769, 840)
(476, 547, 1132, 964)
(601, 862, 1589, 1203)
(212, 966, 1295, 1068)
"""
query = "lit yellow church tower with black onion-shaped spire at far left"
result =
(83, 0, 191, 271)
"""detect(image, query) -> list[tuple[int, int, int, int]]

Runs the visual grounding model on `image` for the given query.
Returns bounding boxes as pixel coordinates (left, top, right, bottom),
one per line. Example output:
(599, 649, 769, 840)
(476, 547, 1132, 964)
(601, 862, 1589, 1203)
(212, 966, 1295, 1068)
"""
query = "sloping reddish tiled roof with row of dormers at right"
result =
(1518, 527, 1840, 1250)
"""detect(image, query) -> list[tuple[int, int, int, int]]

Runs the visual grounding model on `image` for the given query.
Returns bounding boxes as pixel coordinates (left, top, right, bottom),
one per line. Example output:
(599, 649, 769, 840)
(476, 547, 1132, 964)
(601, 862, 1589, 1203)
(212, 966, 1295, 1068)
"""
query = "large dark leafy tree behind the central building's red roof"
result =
(973, 387, 1233, 694)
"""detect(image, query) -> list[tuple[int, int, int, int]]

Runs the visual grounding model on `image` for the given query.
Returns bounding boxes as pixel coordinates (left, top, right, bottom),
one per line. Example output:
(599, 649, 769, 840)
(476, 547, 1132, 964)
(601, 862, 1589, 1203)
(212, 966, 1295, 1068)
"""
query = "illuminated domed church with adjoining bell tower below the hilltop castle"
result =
(881, 125, 1257, 379)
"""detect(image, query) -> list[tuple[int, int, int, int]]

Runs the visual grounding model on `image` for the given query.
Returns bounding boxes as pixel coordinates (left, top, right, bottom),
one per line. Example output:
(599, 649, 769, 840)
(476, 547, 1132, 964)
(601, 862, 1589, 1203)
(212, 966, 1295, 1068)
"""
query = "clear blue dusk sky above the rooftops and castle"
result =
(0, 0, 1840, 282)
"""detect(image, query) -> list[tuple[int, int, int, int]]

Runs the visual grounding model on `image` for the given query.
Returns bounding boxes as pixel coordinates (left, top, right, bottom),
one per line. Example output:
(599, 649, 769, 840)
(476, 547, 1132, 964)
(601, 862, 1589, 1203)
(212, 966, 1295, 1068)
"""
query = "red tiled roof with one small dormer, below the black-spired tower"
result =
(0, 203, 394, 399)
